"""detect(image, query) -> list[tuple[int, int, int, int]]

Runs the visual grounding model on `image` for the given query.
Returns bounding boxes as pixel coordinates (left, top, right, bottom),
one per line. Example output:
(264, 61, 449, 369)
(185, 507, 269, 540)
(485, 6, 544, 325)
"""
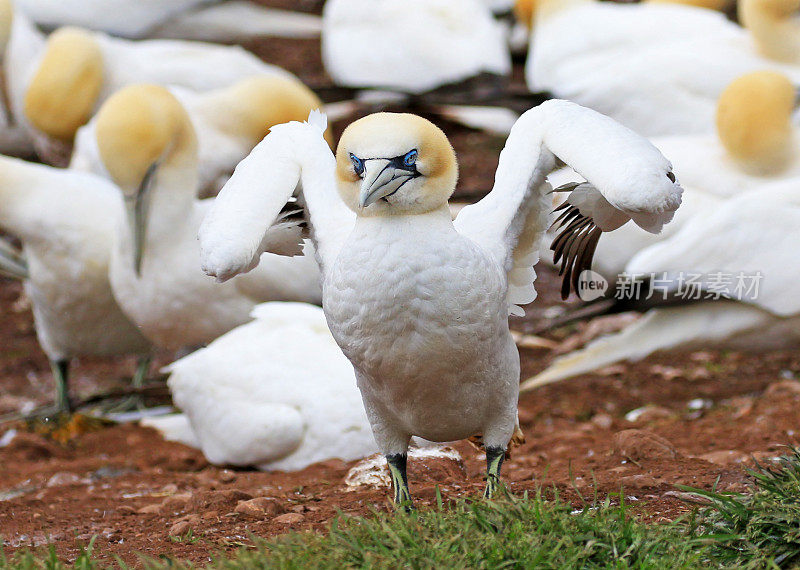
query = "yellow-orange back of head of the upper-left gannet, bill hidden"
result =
(25, 28, 103, 141)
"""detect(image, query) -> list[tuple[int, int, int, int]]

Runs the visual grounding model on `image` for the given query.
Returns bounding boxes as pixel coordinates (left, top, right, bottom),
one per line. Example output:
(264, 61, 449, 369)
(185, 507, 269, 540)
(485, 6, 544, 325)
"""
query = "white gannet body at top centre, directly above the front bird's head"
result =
(322, 0, 511, 93)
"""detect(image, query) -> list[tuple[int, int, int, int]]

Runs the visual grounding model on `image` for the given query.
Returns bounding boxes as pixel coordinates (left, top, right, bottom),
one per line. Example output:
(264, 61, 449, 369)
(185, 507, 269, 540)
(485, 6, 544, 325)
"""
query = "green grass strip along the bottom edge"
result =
(0, 450, 800, 570)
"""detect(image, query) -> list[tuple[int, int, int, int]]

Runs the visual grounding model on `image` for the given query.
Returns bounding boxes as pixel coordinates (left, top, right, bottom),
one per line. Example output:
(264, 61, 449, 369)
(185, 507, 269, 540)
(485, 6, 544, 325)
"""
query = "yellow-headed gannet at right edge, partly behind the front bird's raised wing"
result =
(544, 71, 800, 283)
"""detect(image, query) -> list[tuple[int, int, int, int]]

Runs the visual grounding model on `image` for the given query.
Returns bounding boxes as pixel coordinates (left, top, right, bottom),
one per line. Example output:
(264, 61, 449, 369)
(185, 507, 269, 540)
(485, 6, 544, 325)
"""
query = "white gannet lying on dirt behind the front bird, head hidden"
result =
(147, 303, 376, 471)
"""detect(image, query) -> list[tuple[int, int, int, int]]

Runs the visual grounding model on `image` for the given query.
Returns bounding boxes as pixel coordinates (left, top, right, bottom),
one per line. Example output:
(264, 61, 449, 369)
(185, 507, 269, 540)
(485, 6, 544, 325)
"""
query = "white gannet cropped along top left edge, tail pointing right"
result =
(16, 0, 321, 41)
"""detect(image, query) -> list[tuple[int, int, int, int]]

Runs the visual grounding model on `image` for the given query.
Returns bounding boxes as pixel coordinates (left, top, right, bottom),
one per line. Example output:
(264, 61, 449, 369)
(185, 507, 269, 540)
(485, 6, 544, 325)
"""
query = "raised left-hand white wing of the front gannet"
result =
(199, 112, 355, 281)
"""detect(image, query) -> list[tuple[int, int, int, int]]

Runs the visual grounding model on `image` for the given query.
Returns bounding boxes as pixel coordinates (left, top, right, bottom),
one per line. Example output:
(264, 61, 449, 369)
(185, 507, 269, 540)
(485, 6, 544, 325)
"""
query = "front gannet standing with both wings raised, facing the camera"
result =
(200, 100, 681, 503)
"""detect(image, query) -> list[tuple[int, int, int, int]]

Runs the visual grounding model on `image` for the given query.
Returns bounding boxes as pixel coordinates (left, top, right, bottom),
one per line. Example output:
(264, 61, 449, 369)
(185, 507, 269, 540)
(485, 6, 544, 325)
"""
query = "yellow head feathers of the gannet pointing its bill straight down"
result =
(95, 85, 197, 192)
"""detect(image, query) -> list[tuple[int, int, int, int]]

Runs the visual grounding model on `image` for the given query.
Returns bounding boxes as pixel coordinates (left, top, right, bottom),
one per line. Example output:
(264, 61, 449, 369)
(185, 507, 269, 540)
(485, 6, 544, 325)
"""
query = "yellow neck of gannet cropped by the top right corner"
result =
(739, 0, 800, 63)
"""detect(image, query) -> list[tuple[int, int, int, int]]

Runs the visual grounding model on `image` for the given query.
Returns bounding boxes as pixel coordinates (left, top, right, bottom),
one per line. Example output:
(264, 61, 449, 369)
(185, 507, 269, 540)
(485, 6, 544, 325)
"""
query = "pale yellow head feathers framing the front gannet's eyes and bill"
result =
(336, 113, 458, 214)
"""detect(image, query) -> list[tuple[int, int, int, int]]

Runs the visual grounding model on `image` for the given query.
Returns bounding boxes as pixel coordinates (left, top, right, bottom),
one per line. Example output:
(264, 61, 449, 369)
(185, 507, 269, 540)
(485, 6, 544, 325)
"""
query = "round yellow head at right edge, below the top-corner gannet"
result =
(717, 71, 795, 173)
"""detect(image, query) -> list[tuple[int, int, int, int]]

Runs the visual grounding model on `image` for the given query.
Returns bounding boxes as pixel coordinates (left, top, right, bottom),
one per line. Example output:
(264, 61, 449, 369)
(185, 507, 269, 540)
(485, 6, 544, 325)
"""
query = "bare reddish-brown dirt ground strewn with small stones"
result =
(0, 0, 800, 563)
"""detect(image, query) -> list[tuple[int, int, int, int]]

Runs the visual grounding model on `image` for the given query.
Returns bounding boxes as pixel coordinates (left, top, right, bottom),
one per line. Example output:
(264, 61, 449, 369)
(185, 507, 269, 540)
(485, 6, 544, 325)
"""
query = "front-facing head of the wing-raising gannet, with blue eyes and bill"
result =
(336, 113, 458, 216)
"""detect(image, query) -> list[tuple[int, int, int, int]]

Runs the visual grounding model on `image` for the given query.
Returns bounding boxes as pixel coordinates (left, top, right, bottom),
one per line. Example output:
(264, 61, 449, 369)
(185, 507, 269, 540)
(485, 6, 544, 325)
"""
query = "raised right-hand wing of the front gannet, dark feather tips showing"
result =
(455, 100, 682, 314)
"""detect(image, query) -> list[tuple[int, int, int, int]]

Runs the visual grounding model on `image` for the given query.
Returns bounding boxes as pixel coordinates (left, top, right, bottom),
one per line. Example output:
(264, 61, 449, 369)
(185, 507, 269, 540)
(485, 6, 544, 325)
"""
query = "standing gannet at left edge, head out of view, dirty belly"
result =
(0, 156, 150, 411)
